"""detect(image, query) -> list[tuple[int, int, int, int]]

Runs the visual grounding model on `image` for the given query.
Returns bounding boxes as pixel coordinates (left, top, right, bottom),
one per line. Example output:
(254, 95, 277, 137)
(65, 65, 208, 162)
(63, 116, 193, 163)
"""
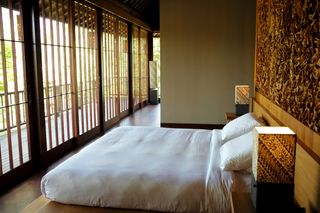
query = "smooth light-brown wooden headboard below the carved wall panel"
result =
(252, 92, 320, 212)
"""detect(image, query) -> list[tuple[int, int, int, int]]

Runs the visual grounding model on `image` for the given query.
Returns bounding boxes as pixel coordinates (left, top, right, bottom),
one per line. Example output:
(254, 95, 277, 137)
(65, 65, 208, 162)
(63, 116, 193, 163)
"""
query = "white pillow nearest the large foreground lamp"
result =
(220, 131, 253, 171)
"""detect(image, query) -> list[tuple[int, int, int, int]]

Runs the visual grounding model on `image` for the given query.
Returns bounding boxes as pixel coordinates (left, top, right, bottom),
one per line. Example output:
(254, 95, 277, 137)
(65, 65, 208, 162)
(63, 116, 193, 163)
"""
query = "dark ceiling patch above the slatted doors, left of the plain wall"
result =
(115, 0, 160, 32)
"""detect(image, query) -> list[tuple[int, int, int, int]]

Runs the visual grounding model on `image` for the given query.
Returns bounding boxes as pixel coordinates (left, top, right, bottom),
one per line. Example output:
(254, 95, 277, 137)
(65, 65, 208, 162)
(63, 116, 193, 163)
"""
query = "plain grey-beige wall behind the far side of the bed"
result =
(160, 0, 255, 124)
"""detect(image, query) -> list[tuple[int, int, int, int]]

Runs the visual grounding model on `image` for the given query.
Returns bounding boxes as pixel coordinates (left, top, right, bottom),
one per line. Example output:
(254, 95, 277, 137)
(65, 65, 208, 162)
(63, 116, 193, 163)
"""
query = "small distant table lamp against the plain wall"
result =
(234, 85, 250, 116)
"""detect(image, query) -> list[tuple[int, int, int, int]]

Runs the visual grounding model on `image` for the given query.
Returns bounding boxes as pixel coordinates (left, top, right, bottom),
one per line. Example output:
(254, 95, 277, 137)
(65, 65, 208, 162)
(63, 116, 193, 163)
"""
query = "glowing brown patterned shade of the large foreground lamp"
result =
(252, 127, 296, 184)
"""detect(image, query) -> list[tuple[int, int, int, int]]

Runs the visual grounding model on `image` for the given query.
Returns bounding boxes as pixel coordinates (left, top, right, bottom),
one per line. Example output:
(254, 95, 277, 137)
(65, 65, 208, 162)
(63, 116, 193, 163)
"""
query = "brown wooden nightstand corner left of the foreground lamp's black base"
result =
(230, 192, 256, 213)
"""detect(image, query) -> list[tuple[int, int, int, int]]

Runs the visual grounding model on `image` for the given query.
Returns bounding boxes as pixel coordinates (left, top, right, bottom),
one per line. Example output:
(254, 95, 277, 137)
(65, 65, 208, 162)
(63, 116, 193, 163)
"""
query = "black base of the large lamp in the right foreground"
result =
(251, 175, 295, 212)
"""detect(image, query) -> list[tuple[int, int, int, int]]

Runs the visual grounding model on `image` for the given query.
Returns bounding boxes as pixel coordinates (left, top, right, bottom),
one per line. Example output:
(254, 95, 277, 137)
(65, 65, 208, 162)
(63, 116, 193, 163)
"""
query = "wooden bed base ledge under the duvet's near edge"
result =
(21, 196, 160, 213)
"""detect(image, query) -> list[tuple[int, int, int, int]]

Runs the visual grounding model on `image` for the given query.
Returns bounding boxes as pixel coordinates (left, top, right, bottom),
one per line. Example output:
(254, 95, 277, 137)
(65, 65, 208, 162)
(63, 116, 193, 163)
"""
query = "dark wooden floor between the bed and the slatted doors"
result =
(0, 104, 160, 213)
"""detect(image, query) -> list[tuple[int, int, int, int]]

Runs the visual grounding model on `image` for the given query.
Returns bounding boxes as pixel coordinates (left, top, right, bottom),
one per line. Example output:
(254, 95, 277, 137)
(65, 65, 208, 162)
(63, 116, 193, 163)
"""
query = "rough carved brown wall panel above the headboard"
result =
(255, 0, 320, 134)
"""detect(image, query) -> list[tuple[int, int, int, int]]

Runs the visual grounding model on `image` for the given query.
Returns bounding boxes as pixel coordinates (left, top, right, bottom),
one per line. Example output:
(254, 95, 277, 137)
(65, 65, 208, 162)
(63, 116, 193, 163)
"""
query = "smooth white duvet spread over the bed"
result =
(41, 127, 230, 212)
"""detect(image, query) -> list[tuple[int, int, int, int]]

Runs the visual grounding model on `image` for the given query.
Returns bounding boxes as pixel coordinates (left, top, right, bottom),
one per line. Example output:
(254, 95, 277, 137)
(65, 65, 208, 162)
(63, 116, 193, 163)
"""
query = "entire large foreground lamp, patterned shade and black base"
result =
(251, 127, 296, 212)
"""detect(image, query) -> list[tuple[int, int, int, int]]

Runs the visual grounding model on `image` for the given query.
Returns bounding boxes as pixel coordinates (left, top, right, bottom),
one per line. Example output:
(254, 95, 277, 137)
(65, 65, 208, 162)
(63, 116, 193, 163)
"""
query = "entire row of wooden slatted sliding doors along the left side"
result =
(0, 0, 149, 187)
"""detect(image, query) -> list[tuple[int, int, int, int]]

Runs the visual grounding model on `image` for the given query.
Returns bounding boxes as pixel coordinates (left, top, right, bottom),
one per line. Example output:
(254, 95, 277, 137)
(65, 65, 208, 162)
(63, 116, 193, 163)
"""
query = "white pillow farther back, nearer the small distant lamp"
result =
(221, 112, 260, 142)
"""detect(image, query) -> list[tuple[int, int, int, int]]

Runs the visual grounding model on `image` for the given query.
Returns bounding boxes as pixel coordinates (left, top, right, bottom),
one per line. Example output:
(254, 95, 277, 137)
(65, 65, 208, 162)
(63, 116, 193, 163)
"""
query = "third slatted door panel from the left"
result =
(74, 2, 100, 135)
